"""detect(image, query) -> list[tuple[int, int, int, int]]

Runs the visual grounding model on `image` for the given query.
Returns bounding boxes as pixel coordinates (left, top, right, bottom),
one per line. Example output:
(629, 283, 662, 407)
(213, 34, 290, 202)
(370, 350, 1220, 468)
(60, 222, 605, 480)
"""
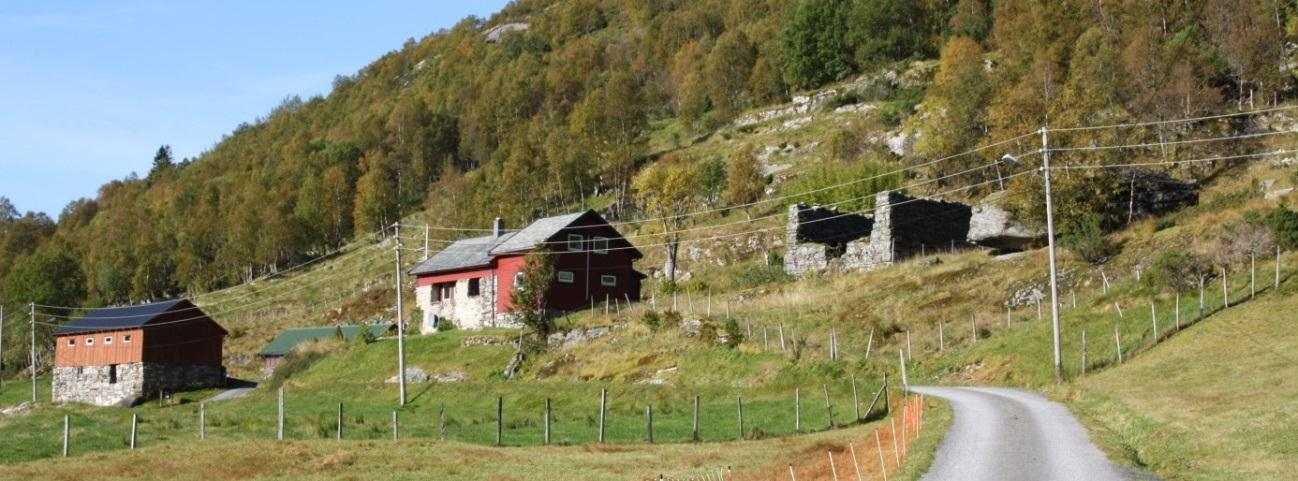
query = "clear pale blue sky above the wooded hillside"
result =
(0, 0, 505, 217)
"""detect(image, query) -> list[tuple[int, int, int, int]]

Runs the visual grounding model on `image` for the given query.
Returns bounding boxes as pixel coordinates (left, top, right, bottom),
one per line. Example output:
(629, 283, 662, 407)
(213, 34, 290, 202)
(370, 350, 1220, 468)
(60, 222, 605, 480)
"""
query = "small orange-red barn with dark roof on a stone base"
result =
(53, 299, 227, 406)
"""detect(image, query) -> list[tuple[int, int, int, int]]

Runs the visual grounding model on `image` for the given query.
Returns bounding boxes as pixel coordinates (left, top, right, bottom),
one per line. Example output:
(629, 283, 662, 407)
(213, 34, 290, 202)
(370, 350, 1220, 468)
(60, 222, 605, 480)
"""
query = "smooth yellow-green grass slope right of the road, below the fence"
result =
(1060, 278, 1298, 480)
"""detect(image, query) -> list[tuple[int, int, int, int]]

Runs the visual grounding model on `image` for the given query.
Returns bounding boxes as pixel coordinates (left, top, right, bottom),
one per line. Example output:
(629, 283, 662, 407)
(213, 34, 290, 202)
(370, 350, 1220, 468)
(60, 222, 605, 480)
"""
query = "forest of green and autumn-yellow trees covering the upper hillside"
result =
(0, 0, 1298, 309)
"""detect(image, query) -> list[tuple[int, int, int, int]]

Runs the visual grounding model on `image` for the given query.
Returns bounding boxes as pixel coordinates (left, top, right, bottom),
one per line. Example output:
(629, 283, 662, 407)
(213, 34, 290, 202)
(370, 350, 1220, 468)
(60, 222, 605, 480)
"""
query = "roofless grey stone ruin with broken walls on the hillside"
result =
(784, 192, 971, 276)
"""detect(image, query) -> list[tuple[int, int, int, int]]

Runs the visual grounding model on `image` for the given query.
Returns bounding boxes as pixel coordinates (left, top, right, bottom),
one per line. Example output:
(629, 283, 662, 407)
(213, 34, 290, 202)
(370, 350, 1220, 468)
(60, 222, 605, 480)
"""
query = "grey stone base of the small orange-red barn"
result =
(53, 363, 226, 406)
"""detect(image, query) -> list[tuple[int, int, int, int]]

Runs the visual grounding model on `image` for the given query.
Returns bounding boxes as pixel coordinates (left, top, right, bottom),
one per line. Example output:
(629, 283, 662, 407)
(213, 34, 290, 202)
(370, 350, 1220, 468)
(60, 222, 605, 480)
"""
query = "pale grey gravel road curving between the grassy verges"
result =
(911, 386, 1158, 481)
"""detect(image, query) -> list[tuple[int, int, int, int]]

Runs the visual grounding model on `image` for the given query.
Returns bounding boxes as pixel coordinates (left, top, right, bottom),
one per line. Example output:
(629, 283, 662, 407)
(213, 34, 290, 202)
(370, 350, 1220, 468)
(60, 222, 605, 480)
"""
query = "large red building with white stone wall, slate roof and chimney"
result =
(410, 210, 644, 332)
